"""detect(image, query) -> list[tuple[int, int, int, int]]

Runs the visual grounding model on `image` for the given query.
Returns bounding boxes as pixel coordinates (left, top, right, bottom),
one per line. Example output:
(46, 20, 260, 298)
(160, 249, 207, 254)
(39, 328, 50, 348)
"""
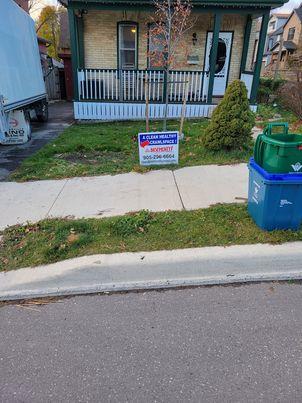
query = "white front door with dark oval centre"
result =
(205, 32, 233, 96)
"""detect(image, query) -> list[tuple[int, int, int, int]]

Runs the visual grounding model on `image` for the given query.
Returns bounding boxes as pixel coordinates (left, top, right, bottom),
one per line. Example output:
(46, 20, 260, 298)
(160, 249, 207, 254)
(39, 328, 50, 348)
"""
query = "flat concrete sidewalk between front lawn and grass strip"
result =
(0, 164, 248, 229)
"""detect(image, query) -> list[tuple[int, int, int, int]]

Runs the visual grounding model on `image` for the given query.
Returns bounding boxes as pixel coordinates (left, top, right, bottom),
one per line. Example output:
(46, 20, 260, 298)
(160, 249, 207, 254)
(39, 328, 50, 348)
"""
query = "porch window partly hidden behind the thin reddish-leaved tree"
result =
(148, 24, 167, 69)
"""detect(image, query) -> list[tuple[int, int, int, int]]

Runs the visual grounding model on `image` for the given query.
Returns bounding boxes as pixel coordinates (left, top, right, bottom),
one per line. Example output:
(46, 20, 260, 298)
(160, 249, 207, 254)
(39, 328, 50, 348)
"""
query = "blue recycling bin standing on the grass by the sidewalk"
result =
(248, 158, 302, 231)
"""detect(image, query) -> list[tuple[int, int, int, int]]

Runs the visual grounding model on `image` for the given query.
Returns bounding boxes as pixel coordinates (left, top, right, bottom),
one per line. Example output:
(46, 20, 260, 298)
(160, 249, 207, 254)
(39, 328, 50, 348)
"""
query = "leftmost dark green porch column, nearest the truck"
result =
(68, 8, 79, 101)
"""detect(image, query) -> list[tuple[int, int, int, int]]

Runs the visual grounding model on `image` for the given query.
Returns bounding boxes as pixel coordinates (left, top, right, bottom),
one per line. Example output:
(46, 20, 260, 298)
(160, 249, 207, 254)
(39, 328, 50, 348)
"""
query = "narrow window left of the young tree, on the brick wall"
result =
(118, 22, 137, 70)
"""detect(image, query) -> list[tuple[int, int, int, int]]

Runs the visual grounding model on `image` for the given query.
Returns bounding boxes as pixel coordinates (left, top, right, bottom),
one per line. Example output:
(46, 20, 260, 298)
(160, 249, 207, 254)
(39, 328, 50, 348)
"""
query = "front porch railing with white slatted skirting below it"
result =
(74, 69, 255, 120)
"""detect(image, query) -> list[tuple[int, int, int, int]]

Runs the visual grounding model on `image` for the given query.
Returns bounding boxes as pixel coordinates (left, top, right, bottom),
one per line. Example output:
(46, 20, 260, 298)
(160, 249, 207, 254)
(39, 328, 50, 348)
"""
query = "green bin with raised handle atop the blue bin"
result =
(254, 123, 302, 173)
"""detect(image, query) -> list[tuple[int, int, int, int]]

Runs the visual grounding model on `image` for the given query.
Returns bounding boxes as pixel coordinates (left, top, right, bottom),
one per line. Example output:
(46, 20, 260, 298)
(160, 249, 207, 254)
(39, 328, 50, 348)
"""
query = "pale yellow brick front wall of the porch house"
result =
(83, 10, 256, 82)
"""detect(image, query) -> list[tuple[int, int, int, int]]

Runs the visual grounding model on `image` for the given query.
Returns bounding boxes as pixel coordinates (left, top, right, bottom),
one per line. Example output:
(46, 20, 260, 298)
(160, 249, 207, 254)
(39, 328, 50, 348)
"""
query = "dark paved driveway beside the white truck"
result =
(0, 101, 73, 181)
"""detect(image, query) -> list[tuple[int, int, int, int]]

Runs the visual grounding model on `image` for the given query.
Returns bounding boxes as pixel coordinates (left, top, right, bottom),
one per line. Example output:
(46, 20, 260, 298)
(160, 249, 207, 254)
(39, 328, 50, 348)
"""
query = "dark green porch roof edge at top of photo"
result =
(65, 0, 288, 11)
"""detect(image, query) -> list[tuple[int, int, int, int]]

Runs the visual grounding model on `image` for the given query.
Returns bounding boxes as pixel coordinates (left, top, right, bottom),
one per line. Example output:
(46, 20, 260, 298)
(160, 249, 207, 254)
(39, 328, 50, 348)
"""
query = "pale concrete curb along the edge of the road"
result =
(0, 242, 302, 300)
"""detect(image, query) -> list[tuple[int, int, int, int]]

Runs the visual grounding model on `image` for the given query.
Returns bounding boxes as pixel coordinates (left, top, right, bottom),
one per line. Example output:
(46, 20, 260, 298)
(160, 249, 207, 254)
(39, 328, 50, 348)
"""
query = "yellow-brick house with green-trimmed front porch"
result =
(62, 0, 284, 120)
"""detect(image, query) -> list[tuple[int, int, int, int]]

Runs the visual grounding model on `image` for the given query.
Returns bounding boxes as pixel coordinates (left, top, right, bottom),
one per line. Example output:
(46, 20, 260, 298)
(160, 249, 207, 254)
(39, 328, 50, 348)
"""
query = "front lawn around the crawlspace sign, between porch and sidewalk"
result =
(10, 119, 252, 181)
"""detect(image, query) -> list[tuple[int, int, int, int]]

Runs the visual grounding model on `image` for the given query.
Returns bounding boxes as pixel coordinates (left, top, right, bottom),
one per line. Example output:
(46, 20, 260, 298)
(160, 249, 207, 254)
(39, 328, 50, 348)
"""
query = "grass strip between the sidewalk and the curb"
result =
(0, 204, 302, 270)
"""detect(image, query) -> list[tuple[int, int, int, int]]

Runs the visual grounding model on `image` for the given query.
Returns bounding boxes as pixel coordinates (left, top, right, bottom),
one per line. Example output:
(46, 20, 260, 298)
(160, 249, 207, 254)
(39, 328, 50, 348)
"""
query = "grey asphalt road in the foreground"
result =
(0, 284, 302, 403)
